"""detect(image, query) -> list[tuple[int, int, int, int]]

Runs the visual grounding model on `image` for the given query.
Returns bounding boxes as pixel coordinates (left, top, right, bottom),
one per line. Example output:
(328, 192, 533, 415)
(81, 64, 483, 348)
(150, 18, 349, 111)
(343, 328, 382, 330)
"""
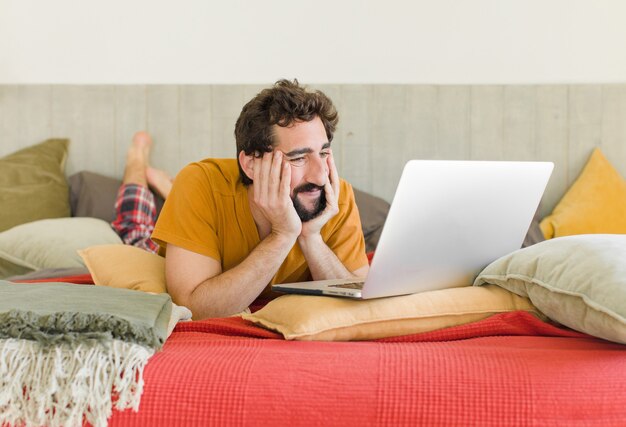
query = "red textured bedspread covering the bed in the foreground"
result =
(111, 312, 626, 426)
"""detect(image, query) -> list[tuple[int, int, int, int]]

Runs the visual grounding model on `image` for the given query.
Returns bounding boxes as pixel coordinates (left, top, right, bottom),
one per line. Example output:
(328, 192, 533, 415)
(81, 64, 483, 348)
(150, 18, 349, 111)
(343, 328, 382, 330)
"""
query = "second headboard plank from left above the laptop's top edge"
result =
(436, 86, 471, 160)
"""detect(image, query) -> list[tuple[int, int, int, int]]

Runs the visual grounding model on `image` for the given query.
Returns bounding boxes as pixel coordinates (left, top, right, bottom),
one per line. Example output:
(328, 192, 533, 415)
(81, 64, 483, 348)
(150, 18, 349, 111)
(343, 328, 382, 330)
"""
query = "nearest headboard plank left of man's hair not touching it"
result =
(180, 85, 212, 167)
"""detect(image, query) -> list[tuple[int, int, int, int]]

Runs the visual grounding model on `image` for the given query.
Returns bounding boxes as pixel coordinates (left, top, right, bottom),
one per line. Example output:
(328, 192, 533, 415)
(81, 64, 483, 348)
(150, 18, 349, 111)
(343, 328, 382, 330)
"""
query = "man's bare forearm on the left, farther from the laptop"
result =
(190, 234, 295, 319)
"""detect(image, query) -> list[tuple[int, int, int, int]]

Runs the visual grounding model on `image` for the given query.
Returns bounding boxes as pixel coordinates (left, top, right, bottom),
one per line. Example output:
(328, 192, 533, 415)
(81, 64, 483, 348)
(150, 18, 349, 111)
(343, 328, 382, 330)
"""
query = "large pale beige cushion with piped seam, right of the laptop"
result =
(474, 234, 626, 344)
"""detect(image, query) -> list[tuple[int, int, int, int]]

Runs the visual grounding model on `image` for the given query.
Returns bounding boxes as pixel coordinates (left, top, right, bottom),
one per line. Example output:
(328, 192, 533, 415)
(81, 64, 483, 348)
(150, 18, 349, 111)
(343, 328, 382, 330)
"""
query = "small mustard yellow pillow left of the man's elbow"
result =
(78, 245, 167, 293)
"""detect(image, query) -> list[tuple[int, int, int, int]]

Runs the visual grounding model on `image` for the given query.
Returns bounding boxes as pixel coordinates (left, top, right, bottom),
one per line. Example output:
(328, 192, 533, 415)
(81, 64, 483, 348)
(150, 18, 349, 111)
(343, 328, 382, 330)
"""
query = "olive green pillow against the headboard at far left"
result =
(0, 139, 70, 231)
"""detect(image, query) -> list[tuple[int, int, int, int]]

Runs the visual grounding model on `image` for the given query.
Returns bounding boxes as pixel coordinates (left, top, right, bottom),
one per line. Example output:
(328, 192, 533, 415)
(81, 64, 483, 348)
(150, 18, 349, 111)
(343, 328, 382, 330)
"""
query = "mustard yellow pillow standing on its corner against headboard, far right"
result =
(540, 148, 626, 239)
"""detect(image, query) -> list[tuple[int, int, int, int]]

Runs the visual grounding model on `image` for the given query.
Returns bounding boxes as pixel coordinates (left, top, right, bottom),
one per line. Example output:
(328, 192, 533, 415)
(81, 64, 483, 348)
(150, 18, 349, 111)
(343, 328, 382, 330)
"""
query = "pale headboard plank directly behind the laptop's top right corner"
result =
(535, 86, 568, 216)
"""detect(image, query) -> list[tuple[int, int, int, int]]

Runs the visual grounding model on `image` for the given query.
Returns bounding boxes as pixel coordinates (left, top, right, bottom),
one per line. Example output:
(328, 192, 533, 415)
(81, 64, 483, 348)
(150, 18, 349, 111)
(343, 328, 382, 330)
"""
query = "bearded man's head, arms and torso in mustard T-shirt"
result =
(152, 80, 368, 319)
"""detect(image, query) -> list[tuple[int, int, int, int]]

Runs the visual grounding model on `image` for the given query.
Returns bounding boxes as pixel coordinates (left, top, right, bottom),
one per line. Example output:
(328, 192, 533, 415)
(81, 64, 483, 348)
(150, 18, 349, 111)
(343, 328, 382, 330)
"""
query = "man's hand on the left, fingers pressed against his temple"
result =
(252, 150, 302, 240)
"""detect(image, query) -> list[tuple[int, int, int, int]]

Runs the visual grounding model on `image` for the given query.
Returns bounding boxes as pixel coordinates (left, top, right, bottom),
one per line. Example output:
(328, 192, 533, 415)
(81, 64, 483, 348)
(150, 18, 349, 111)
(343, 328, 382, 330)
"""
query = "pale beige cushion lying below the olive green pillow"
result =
(0, 218, 122, 277)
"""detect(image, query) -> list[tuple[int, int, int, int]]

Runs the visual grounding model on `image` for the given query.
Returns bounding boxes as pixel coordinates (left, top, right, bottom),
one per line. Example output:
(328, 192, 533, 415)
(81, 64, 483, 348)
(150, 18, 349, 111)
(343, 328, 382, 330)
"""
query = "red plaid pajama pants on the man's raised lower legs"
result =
(111, 184, 159, 253)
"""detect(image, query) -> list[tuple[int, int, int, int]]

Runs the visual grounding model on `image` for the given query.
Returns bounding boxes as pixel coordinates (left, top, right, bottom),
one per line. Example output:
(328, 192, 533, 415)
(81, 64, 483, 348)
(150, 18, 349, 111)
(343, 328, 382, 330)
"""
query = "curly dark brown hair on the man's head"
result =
(235, 79, 339, 185)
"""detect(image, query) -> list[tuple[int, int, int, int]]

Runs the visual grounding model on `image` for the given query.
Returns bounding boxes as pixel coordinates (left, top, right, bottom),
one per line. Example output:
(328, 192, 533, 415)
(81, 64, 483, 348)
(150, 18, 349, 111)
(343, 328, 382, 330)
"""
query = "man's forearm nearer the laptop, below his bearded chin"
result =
(298, 234, 354, 280)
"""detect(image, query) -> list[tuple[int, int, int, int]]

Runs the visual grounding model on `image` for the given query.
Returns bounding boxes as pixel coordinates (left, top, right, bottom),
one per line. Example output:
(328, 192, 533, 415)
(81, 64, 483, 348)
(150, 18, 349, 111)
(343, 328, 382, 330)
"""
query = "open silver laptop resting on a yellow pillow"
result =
(272, 160, 554, 299)
